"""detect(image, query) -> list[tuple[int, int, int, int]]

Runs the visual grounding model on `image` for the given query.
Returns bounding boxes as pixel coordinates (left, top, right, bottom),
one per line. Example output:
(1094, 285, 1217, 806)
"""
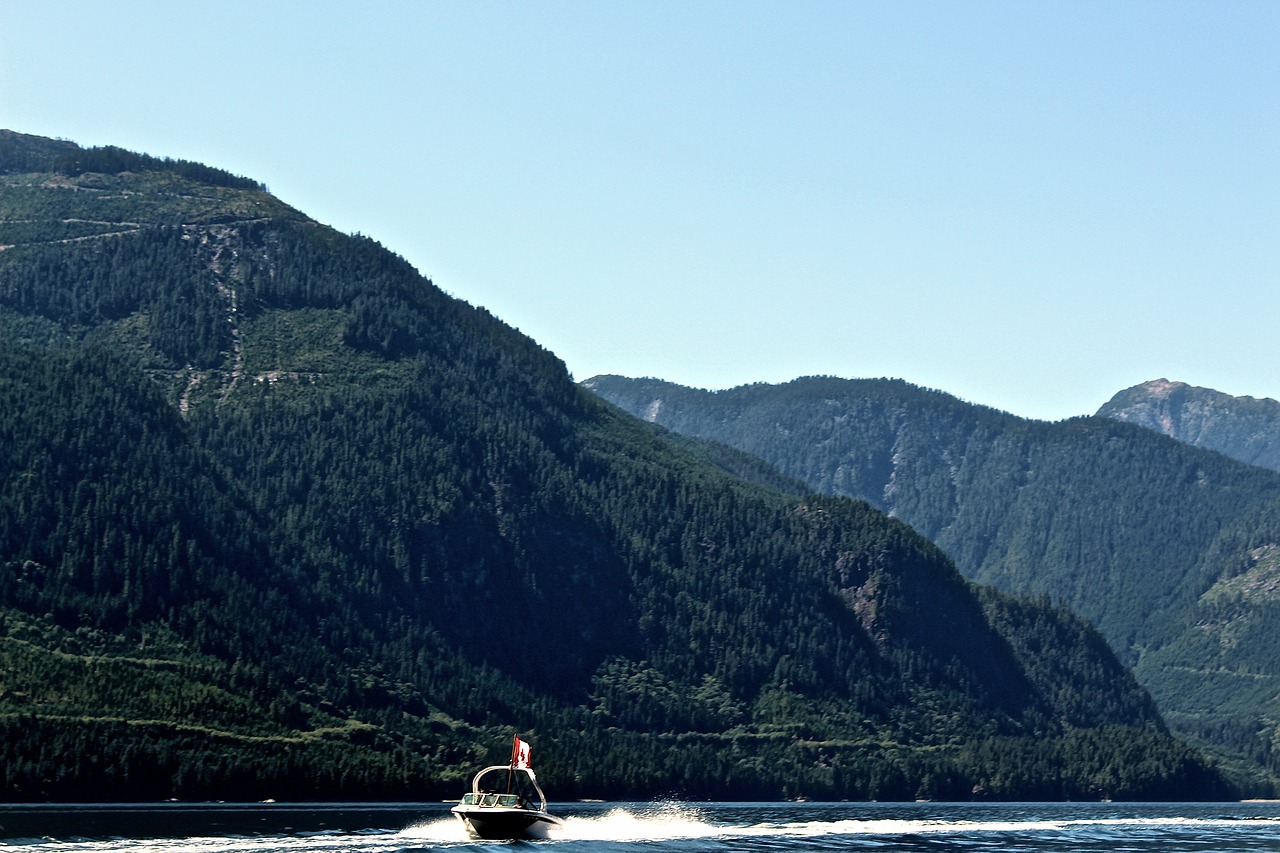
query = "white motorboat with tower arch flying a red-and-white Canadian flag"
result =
(449, 736, 563, 839)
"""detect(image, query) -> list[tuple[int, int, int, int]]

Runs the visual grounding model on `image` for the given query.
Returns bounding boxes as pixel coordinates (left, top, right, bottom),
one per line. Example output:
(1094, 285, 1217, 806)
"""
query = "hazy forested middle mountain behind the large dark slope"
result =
(582, 377, 1280, 790)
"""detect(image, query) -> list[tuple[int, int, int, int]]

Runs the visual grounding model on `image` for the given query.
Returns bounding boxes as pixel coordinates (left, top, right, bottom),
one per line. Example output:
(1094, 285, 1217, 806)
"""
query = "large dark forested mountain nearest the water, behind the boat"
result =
(0, 132, 1228, 800)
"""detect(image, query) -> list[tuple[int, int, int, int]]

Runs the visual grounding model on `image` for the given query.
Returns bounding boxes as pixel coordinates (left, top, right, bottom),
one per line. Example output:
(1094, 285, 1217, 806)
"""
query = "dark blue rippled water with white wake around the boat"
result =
(0, 803, 1280, 853)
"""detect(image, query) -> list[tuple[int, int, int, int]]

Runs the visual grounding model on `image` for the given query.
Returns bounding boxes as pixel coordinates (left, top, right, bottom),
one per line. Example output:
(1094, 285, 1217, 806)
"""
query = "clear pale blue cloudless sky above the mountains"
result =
(0, 0, 1280, 420)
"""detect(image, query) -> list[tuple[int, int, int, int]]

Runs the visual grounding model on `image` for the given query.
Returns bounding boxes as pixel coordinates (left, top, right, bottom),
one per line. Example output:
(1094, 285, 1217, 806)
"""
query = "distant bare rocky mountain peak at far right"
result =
(1097, 379, 1280, 471)
